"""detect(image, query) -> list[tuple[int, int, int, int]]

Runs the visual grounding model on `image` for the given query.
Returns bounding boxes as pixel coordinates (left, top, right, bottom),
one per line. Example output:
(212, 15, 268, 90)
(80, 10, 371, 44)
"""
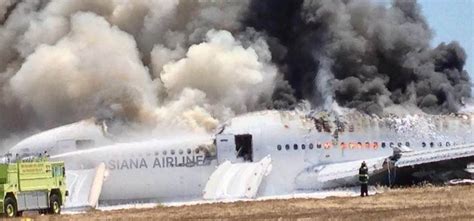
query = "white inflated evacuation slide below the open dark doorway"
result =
(204, 156, 271, 200)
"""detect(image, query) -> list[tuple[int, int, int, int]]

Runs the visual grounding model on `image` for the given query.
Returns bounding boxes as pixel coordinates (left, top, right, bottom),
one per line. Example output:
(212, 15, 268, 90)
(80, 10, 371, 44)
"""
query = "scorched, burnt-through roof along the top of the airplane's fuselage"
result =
(217, 110, 474, 134)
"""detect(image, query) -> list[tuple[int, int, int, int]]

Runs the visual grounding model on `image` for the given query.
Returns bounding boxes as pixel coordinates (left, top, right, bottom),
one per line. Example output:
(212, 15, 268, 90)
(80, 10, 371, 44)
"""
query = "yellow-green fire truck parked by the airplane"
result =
(0, 158, 68, 217)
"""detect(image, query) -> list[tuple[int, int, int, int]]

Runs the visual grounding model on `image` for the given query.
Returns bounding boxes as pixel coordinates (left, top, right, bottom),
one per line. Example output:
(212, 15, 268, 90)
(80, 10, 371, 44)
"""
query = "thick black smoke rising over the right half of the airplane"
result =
(243, 0, 471, 114)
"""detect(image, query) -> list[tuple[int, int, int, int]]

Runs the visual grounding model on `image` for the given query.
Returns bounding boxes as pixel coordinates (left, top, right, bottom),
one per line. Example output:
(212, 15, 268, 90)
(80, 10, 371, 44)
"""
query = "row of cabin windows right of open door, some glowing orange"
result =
(277, 142, 456, 151)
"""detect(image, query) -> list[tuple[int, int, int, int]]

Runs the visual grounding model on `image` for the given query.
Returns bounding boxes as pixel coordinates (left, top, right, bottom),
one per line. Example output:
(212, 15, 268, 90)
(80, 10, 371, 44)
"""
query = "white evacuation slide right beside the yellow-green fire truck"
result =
(65, 163, 106, 210)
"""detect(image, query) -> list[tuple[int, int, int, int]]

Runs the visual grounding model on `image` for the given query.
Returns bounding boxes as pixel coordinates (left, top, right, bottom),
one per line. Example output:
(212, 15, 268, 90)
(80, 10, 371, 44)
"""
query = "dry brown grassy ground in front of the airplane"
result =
(12, 185, 474, 220)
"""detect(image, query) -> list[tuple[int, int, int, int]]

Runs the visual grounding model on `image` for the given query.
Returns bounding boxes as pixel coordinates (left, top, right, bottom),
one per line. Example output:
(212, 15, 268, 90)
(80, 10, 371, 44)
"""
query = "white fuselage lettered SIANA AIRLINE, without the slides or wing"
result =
(6, 111, 474, 201)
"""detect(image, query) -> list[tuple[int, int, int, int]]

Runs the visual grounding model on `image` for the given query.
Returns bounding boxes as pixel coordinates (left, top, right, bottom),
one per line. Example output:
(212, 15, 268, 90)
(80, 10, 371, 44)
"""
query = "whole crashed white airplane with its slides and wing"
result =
(3, 111, 474, 207)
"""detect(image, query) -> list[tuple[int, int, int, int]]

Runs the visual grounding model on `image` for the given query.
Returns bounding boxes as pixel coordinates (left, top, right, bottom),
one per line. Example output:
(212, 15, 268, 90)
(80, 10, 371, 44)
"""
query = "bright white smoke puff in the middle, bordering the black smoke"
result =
(152, 30, 277, 133)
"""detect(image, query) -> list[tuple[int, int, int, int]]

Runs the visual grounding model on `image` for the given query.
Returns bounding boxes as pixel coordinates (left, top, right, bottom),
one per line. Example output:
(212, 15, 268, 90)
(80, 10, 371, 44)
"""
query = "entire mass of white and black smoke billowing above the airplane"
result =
(0, 0, 471, 138)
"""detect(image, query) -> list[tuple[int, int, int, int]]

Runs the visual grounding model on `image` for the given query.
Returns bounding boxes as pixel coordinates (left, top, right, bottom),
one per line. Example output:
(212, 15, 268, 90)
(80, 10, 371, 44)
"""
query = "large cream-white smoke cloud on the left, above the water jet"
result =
(10, 13, 156, 124)
